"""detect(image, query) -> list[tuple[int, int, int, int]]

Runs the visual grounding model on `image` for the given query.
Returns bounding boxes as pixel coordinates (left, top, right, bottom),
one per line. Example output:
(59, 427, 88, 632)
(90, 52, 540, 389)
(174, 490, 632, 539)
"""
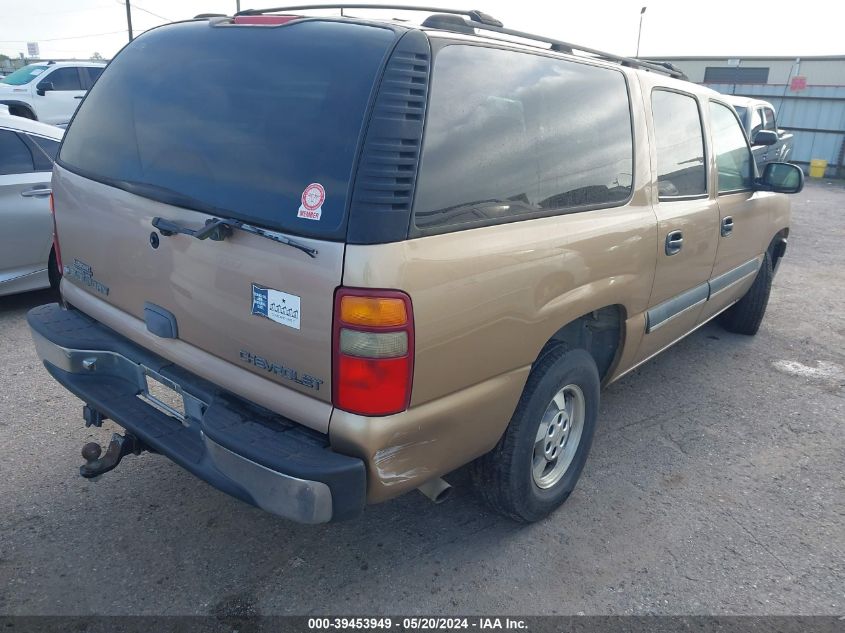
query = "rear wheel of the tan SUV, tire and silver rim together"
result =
(473, 346, 600, 522)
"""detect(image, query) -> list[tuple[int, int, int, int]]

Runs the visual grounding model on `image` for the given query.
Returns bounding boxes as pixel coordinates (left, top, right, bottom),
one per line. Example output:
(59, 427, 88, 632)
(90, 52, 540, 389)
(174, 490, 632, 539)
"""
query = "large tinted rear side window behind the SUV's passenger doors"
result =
(414, 45, 633, 232)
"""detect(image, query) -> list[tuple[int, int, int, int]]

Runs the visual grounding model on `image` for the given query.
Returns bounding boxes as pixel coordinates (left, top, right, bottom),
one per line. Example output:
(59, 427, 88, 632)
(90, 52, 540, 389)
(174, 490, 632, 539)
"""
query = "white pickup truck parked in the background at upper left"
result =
(0, 62, 106, 125)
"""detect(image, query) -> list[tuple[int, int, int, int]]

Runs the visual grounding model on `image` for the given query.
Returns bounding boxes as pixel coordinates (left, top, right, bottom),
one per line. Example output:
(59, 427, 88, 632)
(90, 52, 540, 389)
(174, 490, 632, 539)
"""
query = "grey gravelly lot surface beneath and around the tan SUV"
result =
(0, 183, 845, 615)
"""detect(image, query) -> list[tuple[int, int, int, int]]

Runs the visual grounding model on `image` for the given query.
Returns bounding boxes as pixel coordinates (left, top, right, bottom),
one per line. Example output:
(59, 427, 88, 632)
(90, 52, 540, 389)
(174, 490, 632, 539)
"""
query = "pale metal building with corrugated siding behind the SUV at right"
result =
(652, 55, 845, 178)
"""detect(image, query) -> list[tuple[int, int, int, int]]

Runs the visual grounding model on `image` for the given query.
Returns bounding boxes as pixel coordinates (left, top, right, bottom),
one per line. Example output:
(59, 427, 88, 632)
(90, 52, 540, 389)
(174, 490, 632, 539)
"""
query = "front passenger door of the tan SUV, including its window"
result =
(703, 100, 776, 318)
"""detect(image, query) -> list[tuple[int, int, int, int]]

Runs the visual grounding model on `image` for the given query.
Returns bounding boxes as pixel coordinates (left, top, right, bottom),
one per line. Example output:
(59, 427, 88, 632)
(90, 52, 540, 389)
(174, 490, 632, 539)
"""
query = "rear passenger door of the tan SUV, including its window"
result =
(638, 88, 719, 360)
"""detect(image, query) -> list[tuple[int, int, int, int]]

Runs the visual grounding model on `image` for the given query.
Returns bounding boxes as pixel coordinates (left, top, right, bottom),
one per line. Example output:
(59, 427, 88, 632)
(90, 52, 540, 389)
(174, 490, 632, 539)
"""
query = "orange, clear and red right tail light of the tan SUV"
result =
(332, 288, 414, 416)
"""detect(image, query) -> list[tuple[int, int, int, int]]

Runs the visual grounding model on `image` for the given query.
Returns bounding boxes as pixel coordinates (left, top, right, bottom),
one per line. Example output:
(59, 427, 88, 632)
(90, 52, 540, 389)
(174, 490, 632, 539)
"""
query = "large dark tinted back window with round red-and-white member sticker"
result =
(59, 21, 394, 239)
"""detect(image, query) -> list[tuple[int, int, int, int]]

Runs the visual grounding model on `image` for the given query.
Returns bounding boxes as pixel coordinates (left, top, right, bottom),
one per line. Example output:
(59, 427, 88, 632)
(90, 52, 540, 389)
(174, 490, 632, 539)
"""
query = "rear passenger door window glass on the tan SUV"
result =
(651, 90, 707, 200)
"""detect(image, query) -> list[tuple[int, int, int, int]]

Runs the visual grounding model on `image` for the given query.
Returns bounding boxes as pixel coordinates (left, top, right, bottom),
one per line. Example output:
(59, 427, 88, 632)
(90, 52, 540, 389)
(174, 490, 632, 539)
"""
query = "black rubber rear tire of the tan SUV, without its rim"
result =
(472, 345, 600, 522)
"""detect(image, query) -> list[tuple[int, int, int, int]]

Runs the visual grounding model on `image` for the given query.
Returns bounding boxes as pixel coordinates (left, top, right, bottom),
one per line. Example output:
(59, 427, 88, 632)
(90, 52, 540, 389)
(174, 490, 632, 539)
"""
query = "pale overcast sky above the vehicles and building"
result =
(0, 0, 845, 59)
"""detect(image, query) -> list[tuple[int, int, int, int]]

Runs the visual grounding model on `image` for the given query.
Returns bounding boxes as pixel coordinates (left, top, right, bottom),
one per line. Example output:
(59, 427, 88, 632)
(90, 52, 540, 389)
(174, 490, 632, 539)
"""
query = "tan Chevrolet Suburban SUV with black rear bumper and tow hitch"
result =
(28, 8, 803, 523)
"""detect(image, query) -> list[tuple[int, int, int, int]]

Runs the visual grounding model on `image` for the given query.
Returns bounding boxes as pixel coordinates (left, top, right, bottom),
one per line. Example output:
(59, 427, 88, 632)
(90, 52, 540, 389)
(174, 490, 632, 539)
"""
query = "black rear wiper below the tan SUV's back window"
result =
(112, 180, 317, 258)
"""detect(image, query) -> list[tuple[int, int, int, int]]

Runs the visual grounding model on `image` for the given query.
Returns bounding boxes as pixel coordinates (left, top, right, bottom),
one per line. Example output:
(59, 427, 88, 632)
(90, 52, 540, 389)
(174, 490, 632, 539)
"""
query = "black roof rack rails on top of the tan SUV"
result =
(235, 3, 687, 79)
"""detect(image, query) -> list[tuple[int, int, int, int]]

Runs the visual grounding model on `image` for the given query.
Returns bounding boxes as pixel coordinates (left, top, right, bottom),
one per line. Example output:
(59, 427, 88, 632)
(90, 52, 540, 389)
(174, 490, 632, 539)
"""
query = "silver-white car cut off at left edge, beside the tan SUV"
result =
(0, 113, 64, 296)
